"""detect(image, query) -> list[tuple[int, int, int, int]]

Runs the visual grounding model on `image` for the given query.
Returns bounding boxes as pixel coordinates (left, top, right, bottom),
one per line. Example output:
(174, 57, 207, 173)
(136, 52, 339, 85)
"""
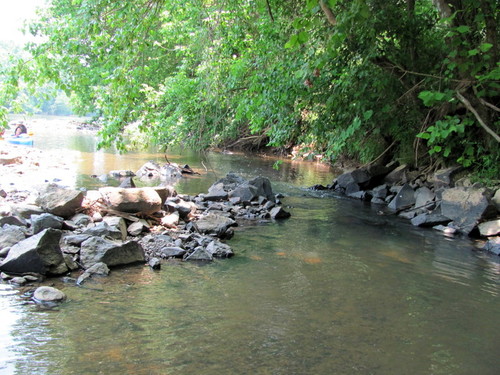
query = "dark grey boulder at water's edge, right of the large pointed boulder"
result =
(80, 237, 145, 269)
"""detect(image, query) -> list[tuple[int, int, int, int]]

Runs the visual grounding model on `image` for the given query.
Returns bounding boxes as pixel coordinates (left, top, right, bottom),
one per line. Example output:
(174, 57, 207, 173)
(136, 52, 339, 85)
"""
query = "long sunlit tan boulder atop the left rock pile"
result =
(99, 187, 162, 214)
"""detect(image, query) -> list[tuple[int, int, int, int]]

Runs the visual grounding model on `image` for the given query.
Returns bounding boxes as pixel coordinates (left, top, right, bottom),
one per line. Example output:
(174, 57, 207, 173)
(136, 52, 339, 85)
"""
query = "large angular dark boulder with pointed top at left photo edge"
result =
(0, 229, 68, 275)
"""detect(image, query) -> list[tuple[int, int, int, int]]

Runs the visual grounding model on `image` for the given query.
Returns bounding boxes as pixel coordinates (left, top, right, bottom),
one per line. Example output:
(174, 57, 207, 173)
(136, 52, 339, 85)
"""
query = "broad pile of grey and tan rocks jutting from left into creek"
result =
(0, 173, 290, 285)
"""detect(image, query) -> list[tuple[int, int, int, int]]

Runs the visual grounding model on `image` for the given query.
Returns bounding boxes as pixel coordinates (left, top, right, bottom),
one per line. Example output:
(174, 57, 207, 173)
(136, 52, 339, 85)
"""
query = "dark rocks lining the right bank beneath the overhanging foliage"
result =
(311, 164, 500, 255)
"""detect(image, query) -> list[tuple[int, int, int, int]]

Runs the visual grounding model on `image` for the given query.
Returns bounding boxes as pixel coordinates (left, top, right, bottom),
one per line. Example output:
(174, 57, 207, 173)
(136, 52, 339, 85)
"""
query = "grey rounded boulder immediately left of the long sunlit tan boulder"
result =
(36, 184, 84, 219)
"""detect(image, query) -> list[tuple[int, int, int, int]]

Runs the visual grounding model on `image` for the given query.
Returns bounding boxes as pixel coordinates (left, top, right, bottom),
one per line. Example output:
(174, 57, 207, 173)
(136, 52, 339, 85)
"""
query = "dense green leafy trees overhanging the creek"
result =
(0, 0, 500, 178)
